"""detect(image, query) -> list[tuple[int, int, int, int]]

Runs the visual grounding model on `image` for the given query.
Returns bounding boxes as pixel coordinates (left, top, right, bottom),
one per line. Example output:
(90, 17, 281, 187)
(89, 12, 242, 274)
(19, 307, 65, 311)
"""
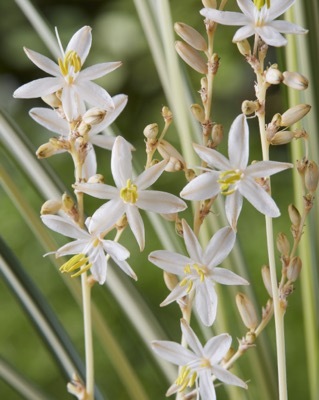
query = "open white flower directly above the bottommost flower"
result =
(149, 220, 248, 326)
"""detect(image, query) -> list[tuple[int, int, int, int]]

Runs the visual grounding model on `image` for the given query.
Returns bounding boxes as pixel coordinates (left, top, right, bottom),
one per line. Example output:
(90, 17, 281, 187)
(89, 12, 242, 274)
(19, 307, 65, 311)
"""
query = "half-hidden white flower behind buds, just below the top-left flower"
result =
(29, 94, 127, 179)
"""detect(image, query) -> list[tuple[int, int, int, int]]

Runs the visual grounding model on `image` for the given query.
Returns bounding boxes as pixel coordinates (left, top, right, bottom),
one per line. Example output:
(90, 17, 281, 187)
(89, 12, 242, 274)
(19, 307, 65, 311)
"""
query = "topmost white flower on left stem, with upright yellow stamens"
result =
(13, 26, 121, 121)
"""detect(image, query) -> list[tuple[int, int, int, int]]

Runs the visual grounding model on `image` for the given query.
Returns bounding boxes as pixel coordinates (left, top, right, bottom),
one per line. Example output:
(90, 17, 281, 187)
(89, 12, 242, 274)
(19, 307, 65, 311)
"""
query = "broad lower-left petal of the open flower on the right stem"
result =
(180, 171, 220, 200)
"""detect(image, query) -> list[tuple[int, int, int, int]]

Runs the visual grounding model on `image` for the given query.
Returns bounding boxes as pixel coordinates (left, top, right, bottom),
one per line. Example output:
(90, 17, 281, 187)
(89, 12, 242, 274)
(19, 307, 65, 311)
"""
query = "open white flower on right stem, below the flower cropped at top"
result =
(181, 114, 293, 229)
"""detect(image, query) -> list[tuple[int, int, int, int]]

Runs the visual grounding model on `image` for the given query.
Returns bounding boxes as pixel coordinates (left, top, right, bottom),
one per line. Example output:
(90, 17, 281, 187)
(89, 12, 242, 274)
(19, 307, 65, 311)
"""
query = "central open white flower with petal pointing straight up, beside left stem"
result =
(76, 136, 186, 250)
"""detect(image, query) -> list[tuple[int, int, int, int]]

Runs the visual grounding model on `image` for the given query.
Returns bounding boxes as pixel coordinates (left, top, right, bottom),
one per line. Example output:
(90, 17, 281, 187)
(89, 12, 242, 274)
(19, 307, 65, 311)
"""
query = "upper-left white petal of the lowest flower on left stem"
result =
(41, 215, 90, 239)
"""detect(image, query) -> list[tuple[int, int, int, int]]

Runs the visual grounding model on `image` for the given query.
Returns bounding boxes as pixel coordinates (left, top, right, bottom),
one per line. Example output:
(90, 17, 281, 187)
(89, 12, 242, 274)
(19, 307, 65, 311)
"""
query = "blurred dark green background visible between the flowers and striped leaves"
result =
(0, 0, 316, 400)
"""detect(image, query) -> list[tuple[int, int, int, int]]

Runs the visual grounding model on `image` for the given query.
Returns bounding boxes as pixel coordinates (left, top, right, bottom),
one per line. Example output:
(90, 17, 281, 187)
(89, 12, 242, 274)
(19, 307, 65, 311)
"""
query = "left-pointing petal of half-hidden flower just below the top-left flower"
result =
(29, 107, 69, 136)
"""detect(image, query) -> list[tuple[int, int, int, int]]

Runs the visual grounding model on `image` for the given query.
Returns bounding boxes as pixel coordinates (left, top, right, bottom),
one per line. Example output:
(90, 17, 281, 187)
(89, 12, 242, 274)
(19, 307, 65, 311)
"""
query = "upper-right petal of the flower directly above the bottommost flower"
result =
(203, 227, 236, 268)
